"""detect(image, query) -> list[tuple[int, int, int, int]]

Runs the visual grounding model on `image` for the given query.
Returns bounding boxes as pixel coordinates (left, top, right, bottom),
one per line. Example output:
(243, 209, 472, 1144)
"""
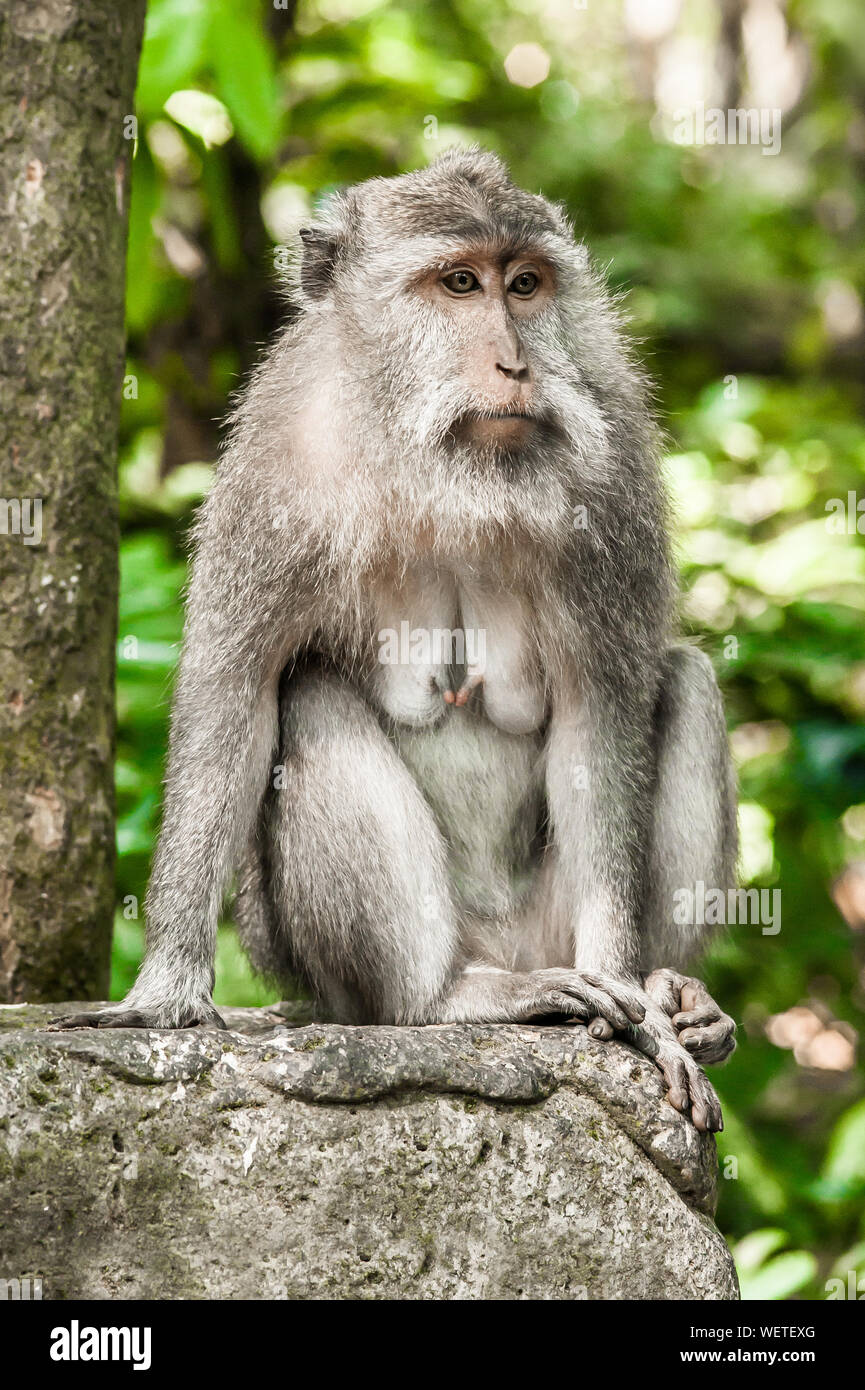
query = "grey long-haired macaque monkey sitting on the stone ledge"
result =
(56, 147, 737, 1131)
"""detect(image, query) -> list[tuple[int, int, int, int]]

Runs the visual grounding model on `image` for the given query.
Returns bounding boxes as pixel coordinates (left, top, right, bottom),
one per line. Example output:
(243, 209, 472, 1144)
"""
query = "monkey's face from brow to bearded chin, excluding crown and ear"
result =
(349, 236, 595, 471)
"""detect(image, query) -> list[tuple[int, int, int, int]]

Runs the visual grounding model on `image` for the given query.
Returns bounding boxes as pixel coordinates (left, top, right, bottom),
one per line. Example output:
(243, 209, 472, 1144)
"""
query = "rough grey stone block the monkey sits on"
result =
(0, 1004, 738, 1300)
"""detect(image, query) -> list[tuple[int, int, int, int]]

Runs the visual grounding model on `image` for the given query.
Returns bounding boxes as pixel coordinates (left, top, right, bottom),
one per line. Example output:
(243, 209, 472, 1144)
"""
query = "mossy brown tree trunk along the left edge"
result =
(0, 0, 145, 1002)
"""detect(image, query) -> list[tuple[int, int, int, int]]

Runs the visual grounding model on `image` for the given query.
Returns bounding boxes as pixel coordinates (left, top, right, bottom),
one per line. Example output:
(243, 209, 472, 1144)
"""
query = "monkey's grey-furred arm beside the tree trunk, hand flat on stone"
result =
(57, 482, 303, 1027)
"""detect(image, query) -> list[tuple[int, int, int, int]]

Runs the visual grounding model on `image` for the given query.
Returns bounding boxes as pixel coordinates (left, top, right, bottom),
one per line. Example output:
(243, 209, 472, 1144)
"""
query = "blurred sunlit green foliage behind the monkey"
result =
(113, 0, 865, 1298)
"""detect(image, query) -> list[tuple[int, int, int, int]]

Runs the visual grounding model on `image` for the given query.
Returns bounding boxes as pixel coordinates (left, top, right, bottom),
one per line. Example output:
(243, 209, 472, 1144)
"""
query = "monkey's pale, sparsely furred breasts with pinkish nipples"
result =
(370, 571, 547, 734)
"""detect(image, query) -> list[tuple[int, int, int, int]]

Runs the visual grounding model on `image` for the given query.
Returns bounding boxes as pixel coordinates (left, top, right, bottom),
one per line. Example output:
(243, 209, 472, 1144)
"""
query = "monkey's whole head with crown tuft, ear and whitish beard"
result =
(299, 152, 619, 487)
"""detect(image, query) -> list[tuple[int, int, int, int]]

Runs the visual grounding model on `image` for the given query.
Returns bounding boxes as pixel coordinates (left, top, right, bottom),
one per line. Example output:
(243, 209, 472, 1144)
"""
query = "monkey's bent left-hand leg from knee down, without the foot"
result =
(267, 670, 458, 1024)
